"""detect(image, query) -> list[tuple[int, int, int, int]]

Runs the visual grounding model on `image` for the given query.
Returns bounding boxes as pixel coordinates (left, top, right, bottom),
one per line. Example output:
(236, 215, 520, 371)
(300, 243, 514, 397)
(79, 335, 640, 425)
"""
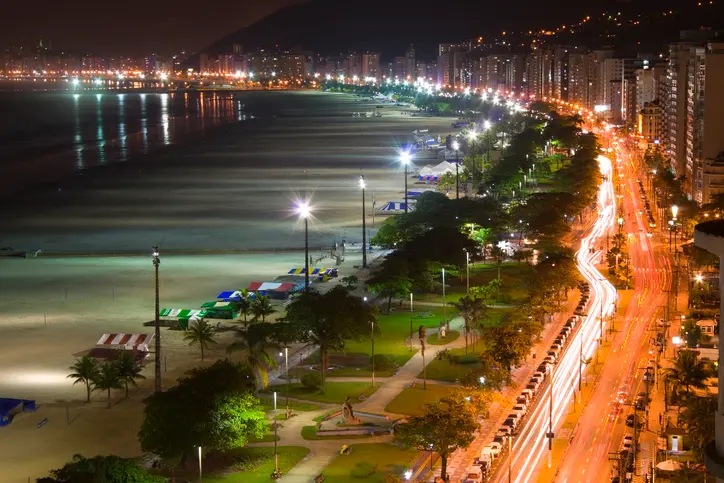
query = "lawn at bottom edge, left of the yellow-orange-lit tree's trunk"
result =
(324, 444, 418, 483)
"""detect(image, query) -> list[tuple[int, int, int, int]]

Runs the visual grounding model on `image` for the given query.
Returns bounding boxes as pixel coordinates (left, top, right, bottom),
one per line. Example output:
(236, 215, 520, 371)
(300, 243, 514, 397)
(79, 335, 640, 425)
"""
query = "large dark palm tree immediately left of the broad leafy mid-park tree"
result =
(226, 322, 279, 388)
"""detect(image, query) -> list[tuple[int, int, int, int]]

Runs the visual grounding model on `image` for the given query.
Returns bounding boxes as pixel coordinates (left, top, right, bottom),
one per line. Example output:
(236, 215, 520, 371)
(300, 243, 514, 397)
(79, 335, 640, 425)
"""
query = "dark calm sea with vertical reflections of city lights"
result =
(0, 88, 253, 197)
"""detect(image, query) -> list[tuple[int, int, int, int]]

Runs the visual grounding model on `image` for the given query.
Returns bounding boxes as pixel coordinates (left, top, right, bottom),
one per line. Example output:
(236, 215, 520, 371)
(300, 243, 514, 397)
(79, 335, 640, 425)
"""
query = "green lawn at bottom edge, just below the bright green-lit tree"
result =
(164, 446, 309, 483)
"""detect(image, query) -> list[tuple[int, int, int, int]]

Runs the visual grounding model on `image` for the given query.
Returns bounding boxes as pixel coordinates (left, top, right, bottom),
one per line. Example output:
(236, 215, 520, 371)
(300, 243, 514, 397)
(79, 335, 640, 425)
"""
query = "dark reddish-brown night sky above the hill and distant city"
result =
(0, 0, 304, 55)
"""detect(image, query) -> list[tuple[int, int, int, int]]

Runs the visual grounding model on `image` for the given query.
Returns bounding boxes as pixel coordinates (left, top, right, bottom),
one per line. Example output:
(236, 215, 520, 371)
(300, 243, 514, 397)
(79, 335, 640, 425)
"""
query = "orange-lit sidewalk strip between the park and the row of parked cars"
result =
(448, 290, 580, 482)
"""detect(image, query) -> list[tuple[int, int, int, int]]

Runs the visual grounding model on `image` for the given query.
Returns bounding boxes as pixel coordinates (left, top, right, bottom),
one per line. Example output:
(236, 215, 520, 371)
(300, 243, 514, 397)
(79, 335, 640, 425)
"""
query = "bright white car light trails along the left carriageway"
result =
(498, 156, 616, 483)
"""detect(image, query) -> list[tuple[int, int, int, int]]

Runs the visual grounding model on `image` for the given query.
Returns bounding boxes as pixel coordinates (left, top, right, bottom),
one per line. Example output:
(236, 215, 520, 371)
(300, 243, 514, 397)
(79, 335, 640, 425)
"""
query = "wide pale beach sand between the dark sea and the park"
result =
(0, 92, 458, 483)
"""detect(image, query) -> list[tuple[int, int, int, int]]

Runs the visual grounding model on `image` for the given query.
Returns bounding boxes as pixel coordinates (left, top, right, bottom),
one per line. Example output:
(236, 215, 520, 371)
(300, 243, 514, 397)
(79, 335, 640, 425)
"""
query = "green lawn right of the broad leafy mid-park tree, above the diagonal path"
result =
(345, 307, 456, 368)
